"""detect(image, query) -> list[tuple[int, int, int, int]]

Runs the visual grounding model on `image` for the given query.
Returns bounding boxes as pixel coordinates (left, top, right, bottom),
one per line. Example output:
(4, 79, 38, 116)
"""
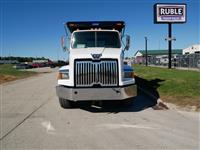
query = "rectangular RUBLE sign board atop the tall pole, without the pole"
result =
(154, 3, 186, 23)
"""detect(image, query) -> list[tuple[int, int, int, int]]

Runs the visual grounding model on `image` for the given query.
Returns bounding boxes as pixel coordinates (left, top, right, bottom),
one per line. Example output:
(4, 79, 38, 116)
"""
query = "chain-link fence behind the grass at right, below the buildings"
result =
(135, 53, 200, 69)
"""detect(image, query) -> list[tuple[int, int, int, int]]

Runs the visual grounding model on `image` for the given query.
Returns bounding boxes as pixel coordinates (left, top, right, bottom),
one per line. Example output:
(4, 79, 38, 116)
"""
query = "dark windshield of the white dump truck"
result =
(72, 31, 121, 48)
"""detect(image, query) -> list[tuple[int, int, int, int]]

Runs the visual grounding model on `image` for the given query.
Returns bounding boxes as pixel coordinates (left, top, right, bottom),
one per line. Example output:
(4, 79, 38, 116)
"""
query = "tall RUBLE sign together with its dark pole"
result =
(154, 3, 186, 69)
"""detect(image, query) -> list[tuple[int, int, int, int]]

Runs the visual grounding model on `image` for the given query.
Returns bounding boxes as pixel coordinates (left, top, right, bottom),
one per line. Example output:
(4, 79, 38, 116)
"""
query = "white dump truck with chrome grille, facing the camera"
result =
(56, 21, 137, 108)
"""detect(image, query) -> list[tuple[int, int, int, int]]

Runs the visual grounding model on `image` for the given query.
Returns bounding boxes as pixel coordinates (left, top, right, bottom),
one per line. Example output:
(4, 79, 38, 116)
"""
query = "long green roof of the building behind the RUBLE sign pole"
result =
(135, 49, 182, 56)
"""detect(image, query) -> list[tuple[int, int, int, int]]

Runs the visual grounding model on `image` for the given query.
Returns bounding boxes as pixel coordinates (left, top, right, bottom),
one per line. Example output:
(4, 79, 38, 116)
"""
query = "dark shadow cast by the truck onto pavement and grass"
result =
(77, 77, 164, 113)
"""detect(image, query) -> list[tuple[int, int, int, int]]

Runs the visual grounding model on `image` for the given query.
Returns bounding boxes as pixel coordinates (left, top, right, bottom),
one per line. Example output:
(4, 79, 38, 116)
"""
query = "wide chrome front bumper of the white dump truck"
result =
(56, 84, 137, 101)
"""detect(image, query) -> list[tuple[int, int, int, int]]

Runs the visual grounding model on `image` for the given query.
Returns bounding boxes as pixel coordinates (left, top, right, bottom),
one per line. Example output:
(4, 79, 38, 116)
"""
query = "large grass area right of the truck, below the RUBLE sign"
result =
(134, 65, 200, 109)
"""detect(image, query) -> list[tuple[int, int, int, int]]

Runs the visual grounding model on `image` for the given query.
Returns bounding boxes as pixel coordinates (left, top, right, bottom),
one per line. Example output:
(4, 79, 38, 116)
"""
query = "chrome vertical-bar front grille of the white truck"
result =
(75, 60, 118, 87)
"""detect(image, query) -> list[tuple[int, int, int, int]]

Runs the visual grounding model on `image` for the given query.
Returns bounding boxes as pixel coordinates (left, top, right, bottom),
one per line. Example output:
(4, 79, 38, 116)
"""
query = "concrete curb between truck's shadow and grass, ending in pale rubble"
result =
(138, 86, 169, 110)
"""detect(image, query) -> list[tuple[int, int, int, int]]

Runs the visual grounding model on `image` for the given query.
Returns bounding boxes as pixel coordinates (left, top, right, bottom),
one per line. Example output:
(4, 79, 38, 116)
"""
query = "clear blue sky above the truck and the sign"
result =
(0, 0, 200, 60)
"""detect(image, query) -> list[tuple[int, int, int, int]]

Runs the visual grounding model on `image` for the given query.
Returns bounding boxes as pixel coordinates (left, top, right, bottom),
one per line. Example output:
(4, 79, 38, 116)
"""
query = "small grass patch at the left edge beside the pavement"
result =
(0, 64, 37, 84)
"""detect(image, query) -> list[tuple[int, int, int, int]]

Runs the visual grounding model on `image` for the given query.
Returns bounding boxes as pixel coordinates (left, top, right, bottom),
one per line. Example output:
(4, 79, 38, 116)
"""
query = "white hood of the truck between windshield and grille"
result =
(70, 47, 122, 59)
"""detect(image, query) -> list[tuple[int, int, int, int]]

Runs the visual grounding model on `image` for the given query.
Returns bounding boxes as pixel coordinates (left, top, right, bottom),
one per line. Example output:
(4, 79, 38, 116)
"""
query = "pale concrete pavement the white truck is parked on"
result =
(0, 71, 200, 150)
